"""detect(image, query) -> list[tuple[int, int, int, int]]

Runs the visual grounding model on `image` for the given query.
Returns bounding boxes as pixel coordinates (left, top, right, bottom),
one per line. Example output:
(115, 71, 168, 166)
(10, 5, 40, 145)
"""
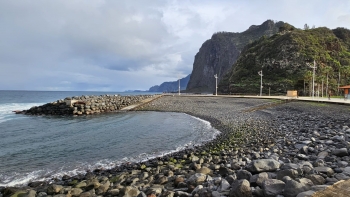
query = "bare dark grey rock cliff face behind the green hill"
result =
(186, 20, 284, 93)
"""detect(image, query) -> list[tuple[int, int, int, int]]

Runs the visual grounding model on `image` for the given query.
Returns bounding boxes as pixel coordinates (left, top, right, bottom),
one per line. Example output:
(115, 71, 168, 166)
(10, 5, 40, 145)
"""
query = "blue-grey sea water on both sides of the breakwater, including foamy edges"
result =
(0, 91, 220, 186)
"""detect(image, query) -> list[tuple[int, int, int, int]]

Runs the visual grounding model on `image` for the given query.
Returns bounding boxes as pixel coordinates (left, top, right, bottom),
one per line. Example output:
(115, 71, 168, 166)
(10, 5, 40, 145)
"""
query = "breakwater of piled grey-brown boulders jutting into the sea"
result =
(20, 95, 154, 115)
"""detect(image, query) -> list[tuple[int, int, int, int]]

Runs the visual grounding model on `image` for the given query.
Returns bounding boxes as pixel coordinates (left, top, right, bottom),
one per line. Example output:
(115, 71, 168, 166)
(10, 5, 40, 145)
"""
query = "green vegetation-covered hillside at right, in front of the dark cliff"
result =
(219, 24, 350, 95)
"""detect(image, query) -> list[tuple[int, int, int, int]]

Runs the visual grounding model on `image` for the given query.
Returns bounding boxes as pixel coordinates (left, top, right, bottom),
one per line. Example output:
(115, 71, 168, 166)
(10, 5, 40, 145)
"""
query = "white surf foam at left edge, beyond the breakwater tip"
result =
(0, 103, 44, 123)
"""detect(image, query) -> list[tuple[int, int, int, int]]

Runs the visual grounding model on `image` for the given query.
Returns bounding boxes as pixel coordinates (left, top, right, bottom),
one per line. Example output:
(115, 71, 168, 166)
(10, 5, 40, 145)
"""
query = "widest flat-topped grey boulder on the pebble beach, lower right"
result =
(247, 159, 280, 173)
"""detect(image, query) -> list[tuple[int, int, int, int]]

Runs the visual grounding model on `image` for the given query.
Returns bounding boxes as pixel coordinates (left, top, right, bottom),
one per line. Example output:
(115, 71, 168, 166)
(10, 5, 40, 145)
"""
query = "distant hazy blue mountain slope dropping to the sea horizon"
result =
(148, 74, 191, 92)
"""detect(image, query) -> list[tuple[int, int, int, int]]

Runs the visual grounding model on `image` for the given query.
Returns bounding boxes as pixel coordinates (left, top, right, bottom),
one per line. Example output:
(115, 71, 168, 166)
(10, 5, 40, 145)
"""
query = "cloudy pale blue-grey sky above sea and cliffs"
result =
(0, 0, 350, 91)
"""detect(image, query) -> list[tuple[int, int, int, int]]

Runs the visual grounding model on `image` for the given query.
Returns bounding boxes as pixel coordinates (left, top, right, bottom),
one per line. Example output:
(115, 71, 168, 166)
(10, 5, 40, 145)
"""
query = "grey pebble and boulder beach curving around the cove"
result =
(1, 96, 350, 197)
